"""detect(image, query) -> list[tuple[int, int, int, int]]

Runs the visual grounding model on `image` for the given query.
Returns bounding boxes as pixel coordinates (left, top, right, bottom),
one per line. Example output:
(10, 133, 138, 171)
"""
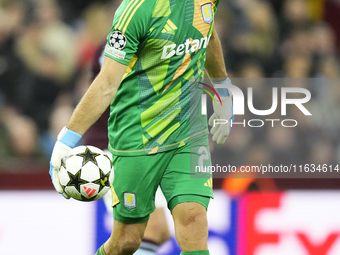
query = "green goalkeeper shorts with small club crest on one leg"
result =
(112, 136, 213, 223)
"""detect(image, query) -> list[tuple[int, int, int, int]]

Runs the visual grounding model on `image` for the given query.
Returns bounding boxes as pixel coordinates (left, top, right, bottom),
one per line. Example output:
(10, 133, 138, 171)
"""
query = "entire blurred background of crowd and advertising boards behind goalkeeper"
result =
(0, 0, 340, 255)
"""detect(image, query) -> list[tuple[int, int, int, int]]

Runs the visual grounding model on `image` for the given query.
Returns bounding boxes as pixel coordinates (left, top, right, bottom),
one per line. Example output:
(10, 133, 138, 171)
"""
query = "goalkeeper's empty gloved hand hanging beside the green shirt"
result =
(209, 78, 234, 144)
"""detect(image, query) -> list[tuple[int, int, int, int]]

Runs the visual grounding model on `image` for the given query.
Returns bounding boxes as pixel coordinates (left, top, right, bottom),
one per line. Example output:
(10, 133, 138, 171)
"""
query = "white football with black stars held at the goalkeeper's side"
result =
(59, 145, 113, 201)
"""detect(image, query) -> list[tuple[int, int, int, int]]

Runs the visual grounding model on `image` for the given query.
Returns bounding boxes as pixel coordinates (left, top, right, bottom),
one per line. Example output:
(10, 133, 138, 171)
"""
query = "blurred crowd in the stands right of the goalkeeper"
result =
(211, 0, 340, 174)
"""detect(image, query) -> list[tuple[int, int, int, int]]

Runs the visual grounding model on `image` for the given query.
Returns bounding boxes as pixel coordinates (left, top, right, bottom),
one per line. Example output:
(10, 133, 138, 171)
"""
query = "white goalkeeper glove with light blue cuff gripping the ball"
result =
(49, 127, 82, 199)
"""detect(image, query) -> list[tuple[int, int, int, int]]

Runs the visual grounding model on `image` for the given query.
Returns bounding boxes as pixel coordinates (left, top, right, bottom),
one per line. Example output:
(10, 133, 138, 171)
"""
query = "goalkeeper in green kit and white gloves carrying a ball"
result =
(51, 0, 232, 255)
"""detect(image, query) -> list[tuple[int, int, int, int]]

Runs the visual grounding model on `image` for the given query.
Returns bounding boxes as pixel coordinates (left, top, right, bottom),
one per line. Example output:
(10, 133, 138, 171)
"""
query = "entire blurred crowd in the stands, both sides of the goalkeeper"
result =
(0, 0, 340, 175)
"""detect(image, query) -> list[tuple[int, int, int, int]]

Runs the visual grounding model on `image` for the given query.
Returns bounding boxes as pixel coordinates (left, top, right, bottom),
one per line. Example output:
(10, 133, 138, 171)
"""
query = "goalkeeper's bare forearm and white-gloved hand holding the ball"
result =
(49, 57, 126, 195)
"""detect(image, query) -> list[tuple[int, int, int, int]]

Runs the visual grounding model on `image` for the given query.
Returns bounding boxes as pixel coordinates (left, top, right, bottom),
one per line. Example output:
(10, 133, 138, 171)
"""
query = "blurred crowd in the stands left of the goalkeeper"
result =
(0, 0, 119, 165)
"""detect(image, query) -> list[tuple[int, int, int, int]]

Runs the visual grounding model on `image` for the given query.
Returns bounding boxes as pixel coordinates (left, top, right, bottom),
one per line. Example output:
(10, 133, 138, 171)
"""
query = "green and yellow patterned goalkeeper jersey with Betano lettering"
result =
(104, 0, 219, 156)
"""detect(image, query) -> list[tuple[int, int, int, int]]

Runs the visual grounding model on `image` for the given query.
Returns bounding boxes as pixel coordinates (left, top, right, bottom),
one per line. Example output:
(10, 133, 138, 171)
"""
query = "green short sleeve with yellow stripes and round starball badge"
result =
(104, 0, 152, 65)
